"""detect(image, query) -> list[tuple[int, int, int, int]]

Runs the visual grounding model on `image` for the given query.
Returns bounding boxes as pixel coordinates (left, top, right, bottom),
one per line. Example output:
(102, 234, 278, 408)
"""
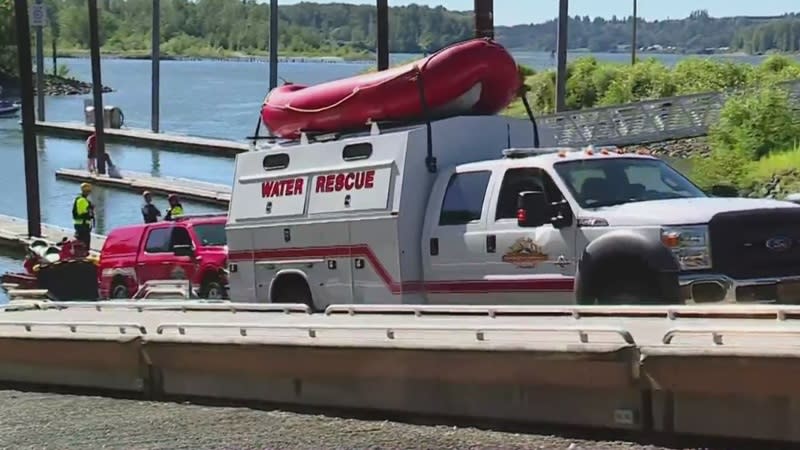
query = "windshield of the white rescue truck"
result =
(555, 158, 706, 208)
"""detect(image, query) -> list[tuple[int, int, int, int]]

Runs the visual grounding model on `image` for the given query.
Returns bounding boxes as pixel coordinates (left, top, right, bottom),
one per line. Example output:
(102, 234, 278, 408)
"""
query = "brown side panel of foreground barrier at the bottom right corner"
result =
(641, 348, 800, 442)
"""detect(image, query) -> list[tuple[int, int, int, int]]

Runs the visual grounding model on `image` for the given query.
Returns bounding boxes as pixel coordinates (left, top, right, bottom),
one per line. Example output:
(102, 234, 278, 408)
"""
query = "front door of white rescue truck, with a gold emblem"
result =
(482, 167, 575, 305)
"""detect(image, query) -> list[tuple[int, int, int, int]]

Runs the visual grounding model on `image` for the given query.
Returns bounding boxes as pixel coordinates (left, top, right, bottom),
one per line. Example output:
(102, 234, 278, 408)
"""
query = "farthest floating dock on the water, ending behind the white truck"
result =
(36, 122, 250, 158)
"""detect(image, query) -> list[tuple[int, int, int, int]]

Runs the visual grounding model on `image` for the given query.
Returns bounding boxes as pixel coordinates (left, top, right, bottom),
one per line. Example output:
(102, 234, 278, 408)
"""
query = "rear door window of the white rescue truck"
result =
(439, 171, 492, 226)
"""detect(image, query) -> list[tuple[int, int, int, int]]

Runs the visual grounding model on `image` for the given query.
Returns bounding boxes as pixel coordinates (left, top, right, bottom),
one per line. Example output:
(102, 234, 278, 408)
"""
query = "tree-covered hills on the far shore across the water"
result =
(0, 0, 800, 78)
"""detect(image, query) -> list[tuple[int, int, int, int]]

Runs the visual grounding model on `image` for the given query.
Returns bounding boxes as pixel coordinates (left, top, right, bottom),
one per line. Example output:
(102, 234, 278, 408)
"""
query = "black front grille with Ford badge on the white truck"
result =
(708, 208, 800, 279)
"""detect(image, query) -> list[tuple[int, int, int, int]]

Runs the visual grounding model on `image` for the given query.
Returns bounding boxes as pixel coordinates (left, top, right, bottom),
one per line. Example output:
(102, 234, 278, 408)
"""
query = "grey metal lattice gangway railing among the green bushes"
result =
(537, 80, 800, 146)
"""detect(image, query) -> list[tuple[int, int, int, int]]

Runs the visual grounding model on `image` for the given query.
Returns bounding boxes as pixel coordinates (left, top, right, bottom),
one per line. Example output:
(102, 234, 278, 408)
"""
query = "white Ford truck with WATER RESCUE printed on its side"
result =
(227, 116, 800, 309)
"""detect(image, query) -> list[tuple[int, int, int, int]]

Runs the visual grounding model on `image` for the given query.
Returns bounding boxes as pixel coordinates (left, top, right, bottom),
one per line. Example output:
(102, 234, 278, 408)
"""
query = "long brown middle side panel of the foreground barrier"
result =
(143, 339, 643, 429)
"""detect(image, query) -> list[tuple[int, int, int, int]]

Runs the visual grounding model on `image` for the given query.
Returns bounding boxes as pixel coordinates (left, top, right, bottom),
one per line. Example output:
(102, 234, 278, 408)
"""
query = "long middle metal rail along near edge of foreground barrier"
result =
(156, 323, 636, 345)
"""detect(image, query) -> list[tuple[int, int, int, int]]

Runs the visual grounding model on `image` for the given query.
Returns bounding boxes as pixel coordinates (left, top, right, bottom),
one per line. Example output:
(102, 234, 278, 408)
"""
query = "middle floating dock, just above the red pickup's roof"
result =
(56, 169, 231, 207)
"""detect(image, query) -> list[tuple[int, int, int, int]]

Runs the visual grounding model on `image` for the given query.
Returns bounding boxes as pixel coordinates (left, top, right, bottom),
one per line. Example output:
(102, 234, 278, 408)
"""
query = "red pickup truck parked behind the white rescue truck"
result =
(98, 215, 228, 299)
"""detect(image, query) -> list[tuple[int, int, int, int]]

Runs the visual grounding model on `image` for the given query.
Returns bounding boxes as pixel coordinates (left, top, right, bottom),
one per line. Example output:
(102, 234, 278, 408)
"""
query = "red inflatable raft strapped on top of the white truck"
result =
(261, 39, 522, 139)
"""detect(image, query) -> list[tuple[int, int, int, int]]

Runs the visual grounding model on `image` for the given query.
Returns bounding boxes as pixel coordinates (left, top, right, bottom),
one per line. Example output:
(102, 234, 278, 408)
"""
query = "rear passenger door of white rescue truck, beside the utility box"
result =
(422, 170, 492, 304)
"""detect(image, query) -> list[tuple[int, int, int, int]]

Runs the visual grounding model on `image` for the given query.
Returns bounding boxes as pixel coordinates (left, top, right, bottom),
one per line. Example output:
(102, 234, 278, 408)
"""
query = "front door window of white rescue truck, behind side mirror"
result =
(495, 167, 564, 220)
